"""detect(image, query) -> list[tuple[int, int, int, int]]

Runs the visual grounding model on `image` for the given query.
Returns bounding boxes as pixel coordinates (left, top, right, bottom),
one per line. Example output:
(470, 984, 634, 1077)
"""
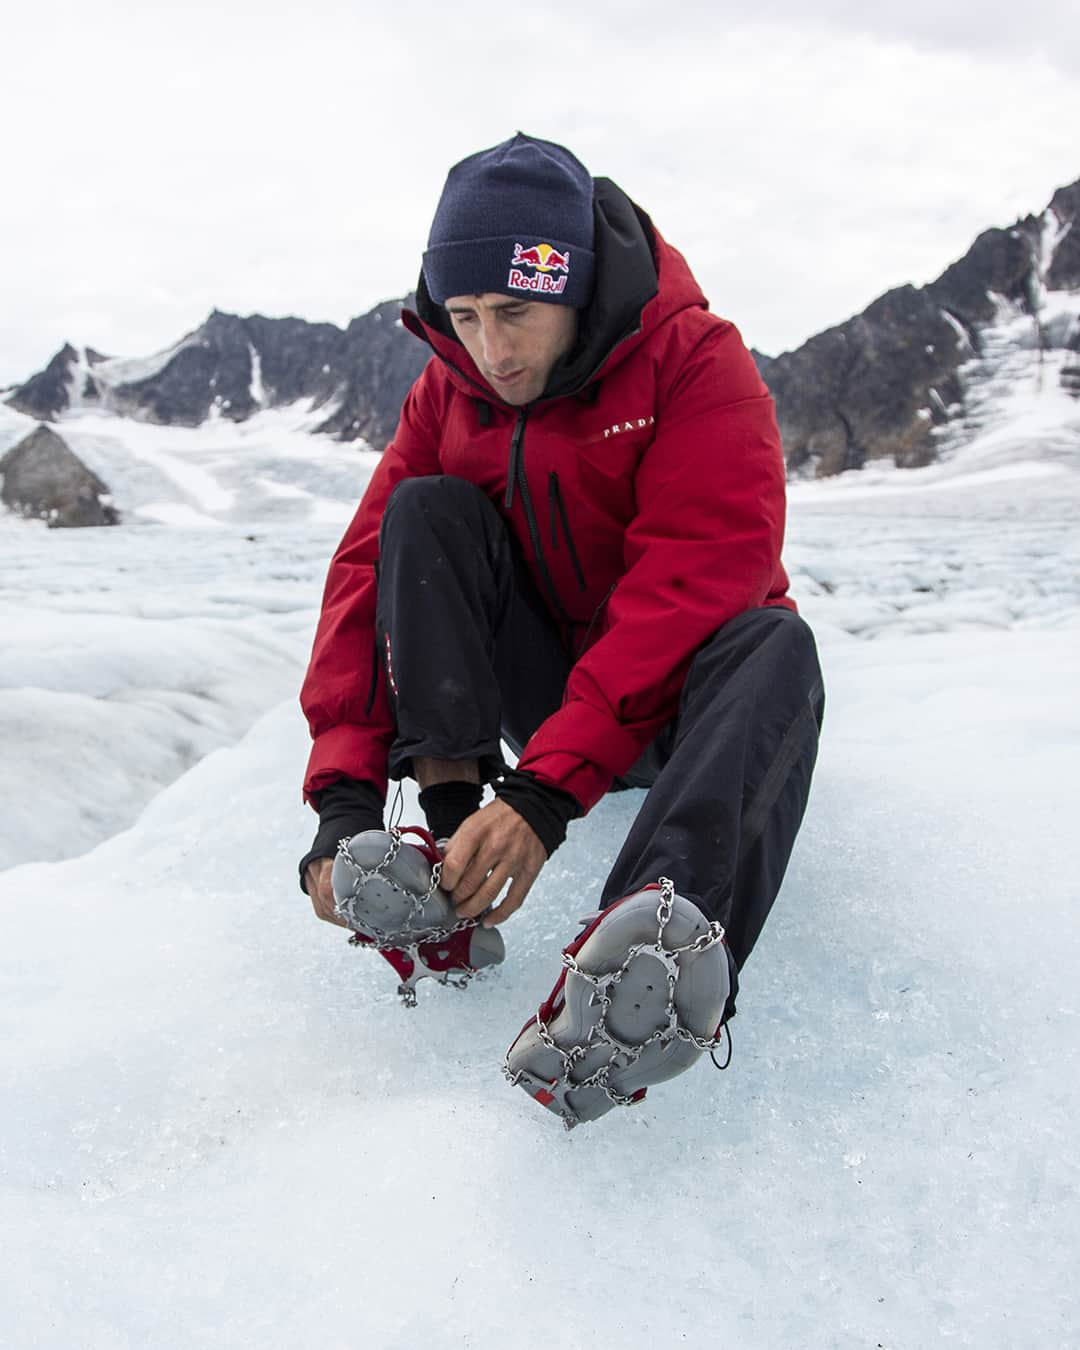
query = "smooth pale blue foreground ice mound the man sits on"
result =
(0, 618, 1080, 1347)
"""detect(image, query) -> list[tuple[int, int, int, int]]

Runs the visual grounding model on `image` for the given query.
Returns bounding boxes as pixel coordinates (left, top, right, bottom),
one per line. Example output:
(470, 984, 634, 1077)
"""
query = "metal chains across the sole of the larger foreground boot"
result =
(504, 876, 724, 1130)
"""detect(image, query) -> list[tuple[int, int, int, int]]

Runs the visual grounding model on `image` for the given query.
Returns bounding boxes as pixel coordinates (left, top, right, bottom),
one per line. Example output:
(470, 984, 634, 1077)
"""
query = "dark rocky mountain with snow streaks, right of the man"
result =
(759, 181, 1080, 477)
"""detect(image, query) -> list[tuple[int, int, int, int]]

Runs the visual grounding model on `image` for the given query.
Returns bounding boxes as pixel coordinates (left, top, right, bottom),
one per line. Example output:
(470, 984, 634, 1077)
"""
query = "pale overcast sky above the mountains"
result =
(0, 0, 1080, 383)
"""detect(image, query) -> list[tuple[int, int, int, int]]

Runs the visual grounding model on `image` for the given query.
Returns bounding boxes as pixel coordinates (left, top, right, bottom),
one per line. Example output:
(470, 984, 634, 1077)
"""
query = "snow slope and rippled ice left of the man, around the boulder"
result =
(0, 408, 375, 865)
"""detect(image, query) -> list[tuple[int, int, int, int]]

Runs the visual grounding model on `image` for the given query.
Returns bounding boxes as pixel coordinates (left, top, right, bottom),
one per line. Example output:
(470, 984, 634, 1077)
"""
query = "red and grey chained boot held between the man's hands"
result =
(331, 826, 505, 1007)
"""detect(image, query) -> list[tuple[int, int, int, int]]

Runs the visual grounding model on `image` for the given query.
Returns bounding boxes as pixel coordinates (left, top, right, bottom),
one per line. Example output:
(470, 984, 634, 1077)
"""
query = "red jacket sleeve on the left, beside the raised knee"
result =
(300, 363, 440, 801)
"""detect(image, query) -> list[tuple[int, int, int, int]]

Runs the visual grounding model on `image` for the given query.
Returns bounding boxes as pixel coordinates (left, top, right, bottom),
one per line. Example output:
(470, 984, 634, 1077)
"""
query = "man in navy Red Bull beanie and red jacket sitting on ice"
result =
(301, 134, 824, 1125)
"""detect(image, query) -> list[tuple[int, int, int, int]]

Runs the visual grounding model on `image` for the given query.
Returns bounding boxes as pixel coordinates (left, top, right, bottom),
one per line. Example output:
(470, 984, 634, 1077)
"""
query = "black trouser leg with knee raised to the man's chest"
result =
(375, 475, 570, 782)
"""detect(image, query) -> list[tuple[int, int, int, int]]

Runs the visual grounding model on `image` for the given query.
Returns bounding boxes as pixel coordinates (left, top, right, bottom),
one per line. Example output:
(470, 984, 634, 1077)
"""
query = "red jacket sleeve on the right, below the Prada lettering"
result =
(510, 320, 794, 810)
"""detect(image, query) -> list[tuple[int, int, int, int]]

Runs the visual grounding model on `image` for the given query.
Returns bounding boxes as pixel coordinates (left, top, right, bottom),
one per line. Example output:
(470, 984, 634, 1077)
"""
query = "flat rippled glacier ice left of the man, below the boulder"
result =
(0, 518, 332, 867)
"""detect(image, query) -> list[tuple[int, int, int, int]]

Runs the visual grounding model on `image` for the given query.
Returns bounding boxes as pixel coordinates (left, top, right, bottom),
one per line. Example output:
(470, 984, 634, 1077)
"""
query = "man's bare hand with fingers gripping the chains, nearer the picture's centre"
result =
(439, 798, 548, 927)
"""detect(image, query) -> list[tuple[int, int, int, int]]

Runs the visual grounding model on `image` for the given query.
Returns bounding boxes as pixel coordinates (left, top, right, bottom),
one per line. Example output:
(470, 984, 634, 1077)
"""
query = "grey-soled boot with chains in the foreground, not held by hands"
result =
(505, 878, 730, 1129)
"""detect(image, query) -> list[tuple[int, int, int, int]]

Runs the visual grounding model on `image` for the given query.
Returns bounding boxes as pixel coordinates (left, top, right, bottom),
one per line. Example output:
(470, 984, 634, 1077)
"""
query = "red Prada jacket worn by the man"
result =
(301, 180, 794, 810)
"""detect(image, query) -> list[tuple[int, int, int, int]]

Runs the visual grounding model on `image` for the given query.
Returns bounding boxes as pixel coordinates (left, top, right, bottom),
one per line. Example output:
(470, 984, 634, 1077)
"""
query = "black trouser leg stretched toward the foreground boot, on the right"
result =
(601, 608, 825, 1010)
